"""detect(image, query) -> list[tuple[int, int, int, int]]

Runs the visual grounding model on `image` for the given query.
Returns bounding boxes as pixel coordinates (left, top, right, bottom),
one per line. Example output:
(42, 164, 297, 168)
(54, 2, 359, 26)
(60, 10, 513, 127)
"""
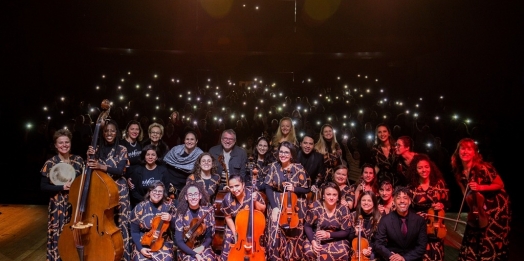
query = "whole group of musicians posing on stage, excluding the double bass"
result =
(41, 119, 511, 261)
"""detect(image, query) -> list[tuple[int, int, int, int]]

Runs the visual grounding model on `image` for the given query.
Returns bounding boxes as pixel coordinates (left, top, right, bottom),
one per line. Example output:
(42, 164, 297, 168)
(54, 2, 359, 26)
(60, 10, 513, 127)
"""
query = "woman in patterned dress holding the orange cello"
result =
(220, 175, 266, 261)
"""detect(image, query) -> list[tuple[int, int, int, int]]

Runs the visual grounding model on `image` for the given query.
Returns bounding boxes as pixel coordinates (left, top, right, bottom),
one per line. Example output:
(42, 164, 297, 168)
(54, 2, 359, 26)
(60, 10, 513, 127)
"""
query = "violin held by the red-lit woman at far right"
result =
(466, 169, 488, 225)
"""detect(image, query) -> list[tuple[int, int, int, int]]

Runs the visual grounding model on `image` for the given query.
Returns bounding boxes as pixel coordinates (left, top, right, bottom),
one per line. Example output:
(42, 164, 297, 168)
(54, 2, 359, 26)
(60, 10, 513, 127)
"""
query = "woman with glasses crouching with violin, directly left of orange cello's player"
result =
(175, 181, 216, 261)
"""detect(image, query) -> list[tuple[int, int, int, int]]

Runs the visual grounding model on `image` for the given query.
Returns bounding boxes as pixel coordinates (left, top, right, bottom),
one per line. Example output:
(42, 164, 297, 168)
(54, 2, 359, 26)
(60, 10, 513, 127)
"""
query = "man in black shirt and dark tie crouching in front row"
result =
(375, 186, 428, 261)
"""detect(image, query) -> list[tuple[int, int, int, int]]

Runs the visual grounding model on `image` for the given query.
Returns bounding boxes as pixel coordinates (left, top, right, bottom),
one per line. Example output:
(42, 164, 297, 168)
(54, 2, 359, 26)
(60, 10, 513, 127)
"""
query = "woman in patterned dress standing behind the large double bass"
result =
(87, 120, 131, 260)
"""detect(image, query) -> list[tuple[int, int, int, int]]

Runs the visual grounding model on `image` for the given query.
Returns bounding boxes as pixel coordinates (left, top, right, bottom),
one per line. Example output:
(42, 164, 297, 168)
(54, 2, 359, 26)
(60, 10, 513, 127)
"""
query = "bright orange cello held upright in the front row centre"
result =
(228, 162, 266, 261)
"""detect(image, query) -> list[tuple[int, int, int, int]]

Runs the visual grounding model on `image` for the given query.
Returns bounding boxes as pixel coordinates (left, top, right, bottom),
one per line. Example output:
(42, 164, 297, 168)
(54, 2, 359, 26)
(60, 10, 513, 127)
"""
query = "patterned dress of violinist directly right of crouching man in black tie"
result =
(411, 180, 449, 261)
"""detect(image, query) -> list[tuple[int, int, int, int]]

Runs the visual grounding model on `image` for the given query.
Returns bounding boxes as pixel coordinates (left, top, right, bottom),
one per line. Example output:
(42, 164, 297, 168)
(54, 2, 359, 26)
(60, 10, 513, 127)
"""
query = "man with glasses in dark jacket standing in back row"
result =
(209, 129, 250, 186)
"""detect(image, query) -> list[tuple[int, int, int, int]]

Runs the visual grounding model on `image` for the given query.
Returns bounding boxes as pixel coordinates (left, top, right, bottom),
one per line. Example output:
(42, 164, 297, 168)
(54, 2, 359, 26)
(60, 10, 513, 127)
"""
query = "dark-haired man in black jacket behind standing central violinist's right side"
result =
(297, 135, 326, 192)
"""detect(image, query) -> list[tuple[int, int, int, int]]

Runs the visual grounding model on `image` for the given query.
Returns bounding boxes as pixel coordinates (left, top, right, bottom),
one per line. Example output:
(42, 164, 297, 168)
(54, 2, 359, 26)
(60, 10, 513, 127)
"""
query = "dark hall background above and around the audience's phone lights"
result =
(0, 0, 524, 223)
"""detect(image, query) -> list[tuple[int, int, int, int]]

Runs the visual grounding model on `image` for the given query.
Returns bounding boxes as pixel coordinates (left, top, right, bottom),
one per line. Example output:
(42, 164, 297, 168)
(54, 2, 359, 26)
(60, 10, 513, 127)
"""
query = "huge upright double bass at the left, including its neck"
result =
(58, 100, 124, 261)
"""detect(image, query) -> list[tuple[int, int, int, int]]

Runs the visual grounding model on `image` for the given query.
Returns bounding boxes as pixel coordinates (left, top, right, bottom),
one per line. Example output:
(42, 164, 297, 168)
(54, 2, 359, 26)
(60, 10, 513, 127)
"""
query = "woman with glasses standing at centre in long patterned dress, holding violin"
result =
(265, 141, 310, 261)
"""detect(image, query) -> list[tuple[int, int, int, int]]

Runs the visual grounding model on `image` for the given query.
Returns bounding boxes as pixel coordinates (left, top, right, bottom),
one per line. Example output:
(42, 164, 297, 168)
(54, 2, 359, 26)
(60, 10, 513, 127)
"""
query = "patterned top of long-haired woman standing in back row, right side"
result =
(370, 145, 404, 187)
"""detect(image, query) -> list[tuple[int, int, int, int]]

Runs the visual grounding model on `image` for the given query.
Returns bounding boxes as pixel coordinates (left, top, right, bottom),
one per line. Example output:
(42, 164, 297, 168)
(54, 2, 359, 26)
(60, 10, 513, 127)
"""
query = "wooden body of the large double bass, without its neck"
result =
(58, 170, 124, 261)
